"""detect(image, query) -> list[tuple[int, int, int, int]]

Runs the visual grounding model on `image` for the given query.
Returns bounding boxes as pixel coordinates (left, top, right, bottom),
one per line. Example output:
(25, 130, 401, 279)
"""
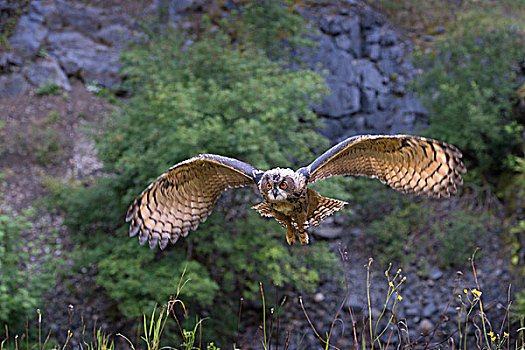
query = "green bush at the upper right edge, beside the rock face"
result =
(415, 11, 524, 183)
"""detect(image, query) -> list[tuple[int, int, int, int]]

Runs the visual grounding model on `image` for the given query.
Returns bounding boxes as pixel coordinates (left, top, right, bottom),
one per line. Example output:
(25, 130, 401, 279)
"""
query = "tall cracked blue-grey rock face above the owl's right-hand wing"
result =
(305, 2, 427, 141)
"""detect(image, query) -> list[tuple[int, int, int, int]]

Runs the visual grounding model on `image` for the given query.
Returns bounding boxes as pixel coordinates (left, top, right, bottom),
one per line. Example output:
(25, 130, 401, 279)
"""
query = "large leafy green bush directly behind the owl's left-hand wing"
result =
(56, 1, 336, 342)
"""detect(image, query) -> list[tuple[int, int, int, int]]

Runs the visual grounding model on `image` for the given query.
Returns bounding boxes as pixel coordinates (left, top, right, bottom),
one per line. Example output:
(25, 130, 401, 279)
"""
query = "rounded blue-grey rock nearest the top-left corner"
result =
(9, 15, 48, 58)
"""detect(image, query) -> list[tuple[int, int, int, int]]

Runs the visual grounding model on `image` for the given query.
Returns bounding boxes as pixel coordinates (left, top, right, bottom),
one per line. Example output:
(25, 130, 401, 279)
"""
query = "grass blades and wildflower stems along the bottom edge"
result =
(0, 250, 525, 350)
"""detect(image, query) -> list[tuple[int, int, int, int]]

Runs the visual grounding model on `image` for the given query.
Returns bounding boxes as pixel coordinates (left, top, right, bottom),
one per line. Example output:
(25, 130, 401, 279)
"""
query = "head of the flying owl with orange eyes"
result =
(259, 168, 300, 201)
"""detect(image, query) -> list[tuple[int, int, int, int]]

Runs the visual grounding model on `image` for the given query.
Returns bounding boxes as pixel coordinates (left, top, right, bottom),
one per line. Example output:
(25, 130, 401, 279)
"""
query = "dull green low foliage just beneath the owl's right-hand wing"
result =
(367, 203, 490, 267)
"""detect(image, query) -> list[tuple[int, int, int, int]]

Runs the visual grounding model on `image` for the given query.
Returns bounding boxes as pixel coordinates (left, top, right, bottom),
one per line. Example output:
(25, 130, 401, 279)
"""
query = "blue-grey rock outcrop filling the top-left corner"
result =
(0, 0, 147, 98)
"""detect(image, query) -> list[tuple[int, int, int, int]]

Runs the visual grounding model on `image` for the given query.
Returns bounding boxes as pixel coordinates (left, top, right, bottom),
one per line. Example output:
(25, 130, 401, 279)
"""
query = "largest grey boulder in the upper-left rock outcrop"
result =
(49, 32, 121, 87)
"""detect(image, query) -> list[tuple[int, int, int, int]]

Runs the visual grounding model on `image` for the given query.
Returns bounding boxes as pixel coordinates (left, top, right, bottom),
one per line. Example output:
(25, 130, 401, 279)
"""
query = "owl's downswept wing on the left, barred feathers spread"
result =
(126, 154, 262, 249)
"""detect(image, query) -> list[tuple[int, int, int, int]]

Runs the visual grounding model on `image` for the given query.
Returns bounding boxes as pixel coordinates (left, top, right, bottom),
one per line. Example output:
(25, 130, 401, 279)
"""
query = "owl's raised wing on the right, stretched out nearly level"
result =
(298, 135, 466, 197)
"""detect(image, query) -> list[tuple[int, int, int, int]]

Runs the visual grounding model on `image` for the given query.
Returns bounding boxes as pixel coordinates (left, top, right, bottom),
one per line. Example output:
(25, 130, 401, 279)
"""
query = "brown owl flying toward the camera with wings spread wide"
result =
(126, 135, 466, 249)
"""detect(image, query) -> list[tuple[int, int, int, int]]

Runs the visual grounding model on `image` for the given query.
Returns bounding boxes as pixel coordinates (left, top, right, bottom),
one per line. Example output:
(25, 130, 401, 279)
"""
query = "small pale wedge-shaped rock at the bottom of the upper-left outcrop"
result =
(23, 57, 71, 91)
